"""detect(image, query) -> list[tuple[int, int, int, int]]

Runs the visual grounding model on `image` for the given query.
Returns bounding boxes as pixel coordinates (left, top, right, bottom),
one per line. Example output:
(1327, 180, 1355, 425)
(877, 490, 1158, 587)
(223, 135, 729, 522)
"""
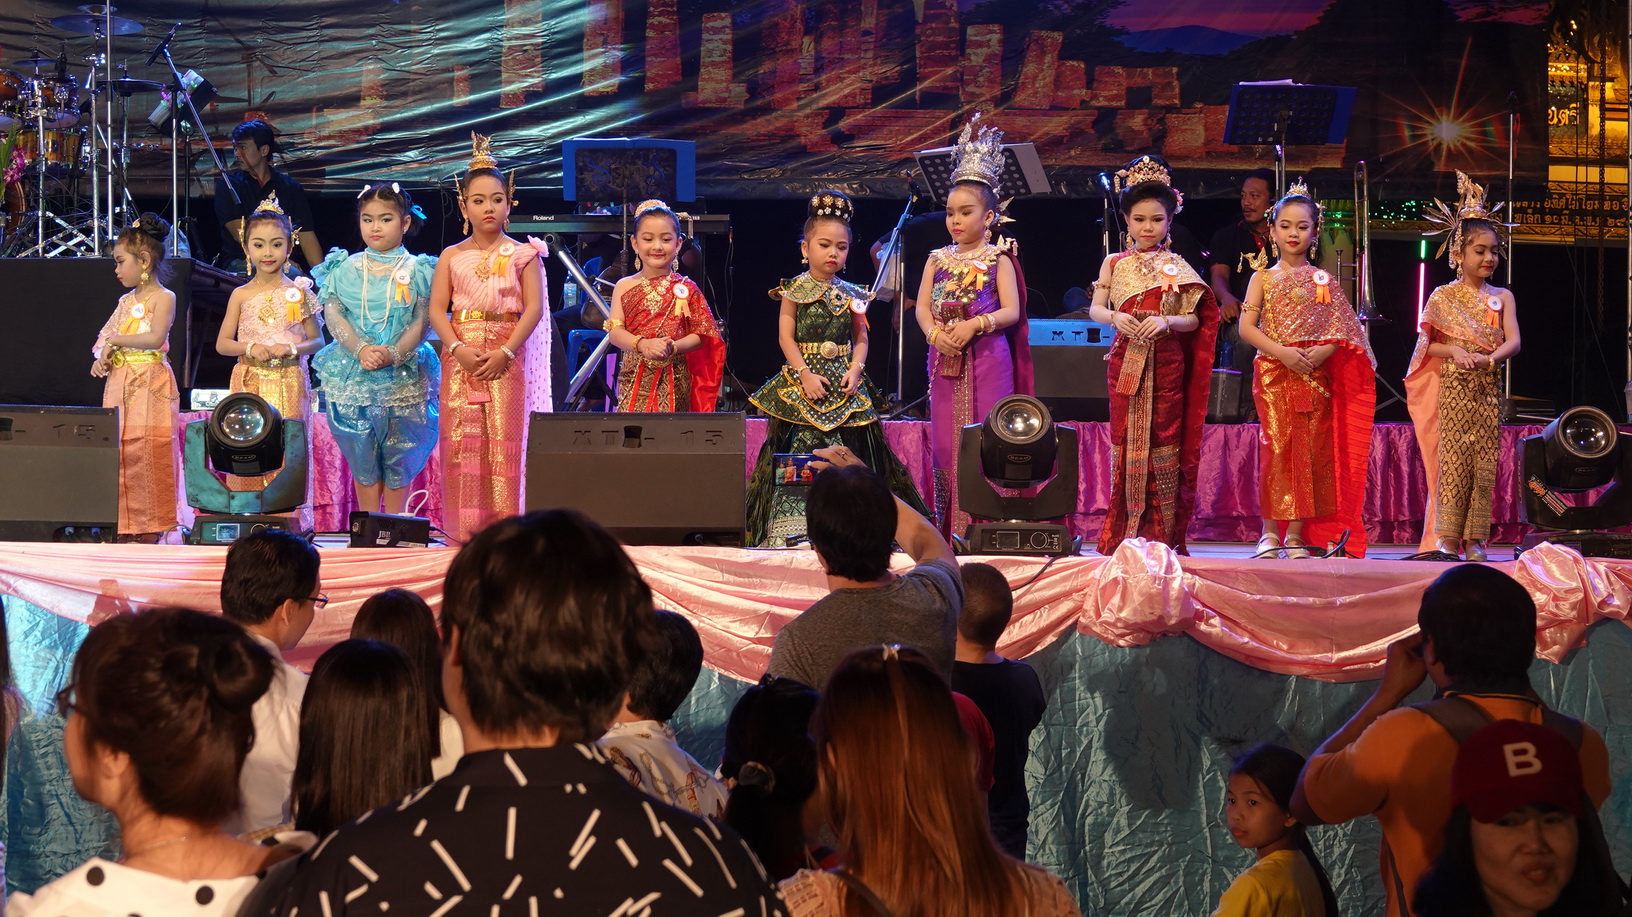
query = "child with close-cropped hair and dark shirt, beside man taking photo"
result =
(951, 563, 1048, 860)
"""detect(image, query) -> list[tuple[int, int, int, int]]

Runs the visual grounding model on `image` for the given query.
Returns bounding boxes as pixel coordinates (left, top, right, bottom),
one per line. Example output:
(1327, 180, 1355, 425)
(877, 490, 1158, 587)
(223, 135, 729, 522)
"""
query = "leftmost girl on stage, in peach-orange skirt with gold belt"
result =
(91, 214, 181, 542)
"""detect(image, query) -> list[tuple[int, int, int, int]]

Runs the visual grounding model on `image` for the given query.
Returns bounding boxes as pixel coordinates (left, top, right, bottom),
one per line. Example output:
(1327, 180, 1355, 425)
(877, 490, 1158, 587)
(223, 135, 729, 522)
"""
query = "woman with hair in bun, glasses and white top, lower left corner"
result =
(8, 609, 310, 917)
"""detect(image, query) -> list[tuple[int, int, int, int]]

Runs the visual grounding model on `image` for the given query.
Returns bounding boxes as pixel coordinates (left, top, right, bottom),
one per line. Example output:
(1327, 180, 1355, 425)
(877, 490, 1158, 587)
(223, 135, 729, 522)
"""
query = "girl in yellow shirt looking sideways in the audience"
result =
(1213, 746, 1337, 917)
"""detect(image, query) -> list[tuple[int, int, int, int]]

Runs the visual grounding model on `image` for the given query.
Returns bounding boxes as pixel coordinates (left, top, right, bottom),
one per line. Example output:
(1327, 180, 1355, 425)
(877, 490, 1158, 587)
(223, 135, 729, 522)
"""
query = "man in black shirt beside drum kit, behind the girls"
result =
(215, 121, 323, 271)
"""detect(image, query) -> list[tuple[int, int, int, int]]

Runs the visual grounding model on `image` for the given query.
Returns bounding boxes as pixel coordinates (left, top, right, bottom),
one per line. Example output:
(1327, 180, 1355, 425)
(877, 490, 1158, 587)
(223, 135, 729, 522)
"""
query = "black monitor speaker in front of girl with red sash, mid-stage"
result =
(527, 413, 747, 547)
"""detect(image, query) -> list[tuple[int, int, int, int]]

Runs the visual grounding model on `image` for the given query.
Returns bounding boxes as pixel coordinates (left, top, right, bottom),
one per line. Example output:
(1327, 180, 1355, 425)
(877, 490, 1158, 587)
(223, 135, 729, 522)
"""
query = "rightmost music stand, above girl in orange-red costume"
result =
(1224, 80, 1355, 196)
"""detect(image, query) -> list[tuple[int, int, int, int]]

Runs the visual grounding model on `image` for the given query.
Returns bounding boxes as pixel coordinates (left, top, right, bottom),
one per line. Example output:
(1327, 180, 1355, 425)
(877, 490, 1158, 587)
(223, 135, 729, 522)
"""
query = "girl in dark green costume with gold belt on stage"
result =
(747, 191, 929, 547)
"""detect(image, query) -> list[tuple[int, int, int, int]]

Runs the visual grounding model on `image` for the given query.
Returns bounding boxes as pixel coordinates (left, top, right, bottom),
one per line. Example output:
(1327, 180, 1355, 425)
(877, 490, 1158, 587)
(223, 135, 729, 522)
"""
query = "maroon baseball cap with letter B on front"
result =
(1451, 720, 1586, 822)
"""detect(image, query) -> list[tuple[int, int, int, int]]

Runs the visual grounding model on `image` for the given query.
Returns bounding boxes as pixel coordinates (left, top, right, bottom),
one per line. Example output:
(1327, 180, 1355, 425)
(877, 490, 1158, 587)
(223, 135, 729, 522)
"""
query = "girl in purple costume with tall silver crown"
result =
(917, 114, 1033, 535)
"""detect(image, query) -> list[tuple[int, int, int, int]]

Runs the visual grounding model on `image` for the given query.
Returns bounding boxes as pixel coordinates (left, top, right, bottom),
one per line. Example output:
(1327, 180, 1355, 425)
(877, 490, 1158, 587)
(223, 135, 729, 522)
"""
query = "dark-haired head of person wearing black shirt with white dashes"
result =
(442, 509, 656, 742)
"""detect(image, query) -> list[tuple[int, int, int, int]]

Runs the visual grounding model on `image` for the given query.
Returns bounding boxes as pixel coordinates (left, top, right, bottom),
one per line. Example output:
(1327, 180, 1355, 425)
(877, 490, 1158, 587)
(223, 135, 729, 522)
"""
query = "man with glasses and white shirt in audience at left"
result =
(220, 530, 328, 834)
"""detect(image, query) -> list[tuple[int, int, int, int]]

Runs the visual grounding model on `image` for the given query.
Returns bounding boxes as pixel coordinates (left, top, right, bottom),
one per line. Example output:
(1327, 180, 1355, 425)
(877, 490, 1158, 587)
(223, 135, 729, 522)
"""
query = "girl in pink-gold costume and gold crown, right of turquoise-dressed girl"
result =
(431, 134, 550, 542)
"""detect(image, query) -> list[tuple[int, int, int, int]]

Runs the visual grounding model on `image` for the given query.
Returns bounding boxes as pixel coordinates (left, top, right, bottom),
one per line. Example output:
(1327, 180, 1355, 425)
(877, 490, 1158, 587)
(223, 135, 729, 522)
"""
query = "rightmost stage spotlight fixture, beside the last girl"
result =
(1519, 406, 1632, 558)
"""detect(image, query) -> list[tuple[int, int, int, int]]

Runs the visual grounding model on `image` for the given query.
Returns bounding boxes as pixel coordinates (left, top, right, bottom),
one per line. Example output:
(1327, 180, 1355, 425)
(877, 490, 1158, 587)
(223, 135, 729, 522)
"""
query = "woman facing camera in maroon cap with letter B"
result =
(1413, 720, 1621, 917)
